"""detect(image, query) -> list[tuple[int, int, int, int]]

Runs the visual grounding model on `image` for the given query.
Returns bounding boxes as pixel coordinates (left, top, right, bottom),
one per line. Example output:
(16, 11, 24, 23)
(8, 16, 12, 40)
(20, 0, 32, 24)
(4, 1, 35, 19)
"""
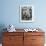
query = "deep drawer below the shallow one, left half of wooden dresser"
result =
(3, 36, 23, 44)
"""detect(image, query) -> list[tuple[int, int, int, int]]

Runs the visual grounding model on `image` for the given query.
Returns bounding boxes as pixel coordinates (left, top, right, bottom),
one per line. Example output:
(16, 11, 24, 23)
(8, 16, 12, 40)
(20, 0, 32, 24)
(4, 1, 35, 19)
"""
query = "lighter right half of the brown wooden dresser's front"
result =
(24, 32, 44, 46)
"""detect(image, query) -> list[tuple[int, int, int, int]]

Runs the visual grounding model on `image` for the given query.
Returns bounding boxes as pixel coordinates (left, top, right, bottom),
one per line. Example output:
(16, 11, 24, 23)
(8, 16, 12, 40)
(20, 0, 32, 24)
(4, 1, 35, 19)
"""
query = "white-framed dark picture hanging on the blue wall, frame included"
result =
(20, 5, 34, 22)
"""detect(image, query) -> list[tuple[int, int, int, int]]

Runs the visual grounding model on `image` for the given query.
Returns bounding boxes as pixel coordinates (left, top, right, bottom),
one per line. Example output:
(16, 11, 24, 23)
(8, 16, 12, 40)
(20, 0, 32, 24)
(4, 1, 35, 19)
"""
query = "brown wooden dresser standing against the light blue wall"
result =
(2, 29, 45, 46)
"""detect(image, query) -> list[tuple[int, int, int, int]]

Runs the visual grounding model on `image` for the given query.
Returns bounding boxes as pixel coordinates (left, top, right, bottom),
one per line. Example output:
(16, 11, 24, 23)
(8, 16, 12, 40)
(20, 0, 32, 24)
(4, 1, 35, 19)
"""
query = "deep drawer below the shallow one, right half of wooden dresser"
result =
(24, 36, 44, 44)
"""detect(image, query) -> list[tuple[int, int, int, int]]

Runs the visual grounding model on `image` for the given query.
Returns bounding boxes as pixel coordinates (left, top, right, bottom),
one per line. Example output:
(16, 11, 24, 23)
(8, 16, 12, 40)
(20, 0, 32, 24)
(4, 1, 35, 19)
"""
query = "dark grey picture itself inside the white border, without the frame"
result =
(22, 8, 32, 20)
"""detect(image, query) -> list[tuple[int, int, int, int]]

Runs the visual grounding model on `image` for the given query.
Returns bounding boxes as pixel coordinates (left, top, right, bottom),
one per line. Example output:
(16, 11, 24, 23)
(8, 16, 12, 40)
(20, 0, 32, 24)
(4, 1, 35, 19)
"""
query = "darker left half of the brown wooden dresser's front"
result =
(3, 32, 23, 46)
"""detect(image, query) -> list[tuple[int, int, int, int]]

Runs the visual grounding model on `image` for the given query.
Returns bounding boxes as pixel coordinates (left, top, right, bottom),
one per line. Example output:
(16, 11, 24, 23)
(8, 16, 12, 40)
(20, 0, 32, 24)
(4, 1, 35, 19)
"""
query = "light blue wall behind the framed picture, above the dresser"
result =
(0, 0, 46, 28)
